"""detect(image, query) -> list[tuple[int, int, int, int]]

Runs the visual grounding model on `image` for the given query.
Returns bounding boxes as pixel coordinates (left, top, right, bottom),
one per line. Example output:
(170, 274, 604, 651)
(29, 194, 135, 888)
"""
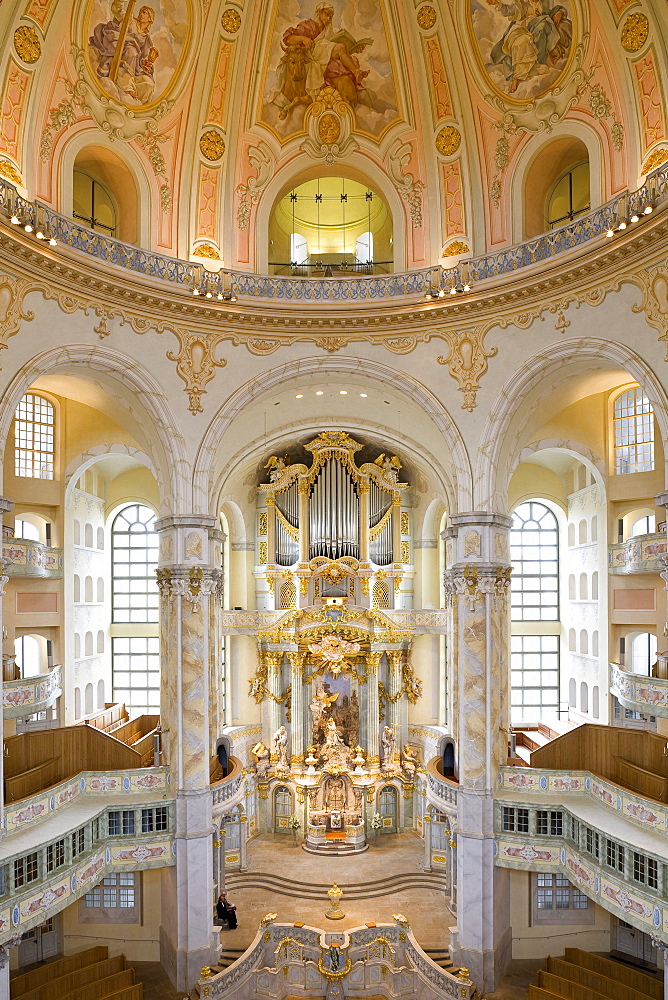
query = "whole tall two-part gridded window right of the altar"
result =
(510, 500, 559, 723)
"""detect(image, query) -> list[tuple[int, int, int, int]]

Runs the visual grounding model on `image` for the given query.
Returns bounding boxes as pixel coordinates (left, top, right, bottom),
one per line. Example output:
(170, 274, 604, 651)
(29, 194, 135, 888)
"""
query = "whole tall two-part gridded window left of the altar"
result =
(111, 503, 160, 717)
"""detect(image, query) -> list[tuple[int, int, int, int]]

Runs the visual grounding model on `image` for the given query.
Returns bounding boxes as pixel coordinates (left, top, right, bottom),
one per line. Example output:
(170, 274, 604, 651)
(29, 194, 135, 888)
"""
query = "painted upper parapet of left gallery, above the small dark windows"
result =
(4, 767, 172, 835)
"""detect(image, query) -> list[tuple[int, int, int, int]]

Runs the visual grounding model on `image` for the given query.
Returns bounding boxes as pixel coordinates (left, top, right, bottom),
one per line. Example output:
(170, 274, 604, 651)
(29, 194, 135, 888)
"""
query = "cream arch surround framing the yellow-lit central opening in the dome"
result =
(255, 150, 408, 274)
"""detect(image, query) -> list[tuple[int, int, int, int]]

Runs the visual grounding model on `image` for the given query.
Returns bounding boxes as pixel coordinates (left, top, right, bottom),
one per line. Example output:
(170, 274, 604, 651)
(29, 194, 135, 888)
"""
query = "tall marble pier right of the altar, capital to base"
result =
(445, 511, 512, 992)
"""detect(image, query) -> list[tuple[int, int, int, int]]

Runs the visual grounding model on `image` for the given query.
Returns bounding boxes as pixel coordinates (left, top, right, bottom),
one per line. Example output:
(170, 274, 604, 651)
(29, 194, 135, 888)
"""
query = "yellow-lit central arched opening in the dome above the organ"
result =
(268, 177, 394, 277)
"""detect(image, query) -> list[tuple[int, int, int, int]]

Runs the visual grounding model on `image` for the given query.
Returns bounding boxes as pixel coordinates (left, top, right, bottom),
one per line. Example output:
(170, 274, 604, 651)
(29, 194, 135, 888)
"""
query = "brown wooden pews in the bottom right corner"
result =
(529, 948, 664, 1000)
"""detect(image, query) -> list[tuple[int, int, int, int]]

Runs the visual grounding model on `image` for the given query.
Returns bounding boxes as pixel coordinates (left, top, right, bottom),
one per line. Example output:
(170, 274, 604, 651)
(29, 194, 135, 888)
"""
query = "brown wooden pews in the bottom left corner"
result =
(10, 947, 143, 1000)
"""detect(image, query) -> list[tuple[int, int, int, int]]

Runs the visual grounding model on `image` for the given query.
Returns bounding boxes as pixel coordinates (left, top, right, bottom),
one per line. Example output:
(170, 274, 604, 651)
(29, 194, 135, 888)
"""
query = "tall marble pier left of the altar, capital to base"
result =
(156, 515, 221, 992)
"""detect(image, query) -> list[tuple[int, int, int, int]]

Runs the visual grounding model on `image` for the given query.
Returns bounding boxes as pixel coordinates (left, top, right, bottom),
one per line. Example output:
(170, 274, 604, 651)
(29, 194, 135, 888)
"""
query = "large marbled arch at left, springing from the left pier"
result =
(0, 345, 189, 513)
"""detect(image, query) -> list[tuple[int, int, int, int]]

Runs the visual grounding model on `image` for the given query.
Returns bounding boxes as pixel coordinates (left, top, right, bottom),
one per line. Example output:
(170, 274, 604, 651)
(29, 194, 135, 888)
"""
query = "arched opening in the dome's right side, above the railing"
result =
(524, 136, 591, 239)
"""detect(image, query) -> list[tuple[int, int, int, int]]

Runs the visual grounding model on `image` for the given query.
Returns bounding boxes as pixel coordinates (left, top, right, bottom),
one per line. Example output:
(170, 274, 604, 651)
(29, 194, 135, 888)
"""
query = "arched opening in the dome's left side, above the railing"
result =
(72, 146, 138, 243)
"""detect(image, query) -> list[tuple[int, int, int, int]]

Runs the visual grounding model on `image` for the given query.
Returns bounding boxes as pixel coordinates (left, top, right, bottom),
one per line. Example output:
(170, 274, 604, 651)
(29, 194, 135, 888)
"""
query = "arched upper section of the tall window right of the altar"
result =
(510, 500, 559, 622)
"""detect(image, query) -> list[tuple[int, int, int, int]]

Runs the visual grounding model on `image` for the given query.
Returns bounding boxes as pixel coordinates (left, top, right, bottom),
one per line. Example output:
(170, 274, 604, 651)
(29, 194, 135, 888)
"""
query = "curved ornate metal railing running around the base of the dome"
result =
(0, 164, 668, 302)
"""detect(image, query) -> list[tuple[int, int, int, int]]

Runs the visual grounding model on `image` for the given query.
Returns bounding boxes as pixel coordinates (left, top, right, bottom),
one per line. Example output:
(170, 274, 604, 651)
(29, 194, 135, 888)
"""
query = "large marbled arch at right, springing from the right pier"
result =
(474, 338, 668, 514)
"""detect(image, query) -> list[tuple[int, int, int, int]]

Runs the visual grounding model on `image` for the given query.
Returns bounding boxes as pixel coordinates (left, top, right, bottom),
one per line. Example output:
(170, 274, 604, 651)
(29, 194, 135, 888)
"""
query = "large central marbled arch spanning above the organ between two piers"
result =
(193, 357, 473, 512)
